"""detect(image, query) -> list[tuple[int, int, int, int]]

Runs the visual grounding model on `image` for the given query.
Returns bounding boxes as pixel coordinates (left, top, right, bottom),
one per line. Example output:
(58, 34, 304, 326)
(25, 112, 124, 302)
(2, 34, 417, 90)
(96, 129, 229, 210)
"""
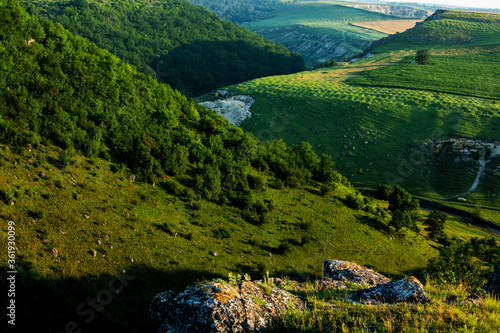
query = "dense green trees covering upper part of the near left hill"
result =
(0, 0, 342, 202)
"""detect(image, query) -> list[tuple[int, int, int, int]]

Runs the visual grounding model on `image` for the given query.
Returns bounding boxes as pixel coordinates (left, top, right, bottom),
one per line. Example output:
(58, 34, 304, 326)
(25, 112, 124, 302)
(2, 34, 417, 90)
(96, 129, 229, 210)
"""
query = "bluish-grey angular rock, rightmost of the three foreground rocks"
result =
(351, 276, 430, 303)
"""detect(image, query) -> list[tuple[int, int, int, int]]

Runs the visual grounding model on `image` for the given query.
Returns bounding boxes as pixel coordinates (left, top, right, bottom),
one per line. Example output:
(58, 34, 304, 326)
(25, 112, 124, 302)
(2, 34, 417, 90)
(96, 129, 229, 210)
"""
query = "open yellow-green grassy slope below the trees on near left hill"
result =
(0, 142, 496, 332)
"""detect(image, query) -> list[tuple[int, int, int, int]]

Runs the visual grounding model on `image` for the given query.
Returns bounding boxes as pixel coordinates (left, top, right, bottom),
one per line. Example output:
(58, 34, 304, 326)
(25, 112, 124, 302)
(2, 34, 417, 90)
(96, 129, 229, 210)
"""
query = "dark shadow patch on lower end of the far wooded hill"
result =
(151, 40, 305, 96)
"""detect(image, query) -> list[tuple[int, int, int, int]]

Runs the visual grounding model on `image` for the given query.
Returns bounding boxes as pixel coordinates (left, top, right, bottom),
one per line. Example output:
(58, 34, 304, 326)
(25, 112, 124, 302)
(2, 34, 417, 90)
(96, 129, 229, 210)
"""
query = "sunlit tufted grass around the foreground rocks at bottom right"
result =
(271, 282, 500, 332)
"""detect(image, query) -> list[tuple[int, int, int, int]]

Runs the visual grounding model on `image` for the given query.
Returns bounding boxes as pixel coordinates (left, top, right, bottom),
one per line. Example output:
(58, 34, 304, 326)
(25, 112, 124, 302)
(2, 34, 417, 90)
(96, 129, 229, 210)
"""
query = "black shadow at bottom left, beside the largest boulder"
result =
(2, 265, 220, 333)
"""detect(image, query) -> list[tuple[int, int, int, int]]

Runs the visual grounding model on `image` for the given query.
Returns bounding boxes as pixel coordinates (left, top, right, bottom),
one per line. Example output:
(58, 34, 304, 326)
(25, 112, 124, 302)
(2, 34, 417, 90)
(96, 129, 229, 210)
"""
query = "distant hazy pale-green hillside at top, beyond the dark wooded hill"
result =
(240, 1, 424, 66)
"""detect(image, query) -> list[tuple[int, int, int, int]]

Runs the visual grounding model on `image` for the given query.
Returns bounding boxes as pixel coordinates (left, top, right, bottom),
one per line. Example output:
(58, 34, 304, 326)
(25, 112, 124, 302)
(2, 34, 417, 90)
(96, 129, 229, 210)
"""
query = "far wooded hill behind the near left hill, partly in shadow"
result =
(20, 0, 304, 95)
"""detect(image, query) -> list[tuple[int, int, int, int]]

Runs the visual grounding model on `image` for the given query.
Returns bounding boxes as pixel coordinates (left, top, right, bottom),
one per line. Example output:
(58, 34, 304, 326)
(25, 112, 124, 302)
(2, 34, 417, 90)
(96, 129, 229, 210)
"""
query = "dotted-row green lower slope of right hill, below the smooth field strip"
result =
(231, 65, 500, 205)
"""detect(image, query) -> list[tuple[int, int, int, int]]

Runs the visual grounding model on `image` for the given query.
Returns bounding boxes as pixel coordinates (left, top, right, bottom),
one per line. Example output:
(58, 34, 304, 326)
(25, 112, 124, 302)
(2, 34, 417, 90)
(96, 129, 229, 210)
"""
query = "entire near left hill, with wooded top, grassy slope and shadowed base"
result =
(0, 0, 497, 332)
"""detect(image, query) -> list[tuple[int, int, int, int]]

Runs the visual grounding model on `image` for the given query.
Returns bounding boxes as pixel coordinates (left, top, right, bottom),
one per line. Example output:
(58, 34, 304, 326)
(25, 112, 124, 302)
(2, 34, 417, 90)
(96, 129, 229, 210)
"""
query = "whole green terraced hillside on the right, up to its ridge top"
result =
(223, 12, 500, 214)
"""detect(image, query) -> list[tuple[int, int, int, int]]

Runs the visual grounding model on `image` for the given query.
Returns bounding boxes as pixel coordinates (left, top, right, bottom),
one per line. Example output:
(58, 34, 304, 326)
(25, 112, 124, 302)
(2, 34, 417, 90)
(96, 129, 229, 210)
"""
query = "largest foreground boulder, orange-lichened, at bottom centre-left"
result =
(149, 281, 304, 333)
